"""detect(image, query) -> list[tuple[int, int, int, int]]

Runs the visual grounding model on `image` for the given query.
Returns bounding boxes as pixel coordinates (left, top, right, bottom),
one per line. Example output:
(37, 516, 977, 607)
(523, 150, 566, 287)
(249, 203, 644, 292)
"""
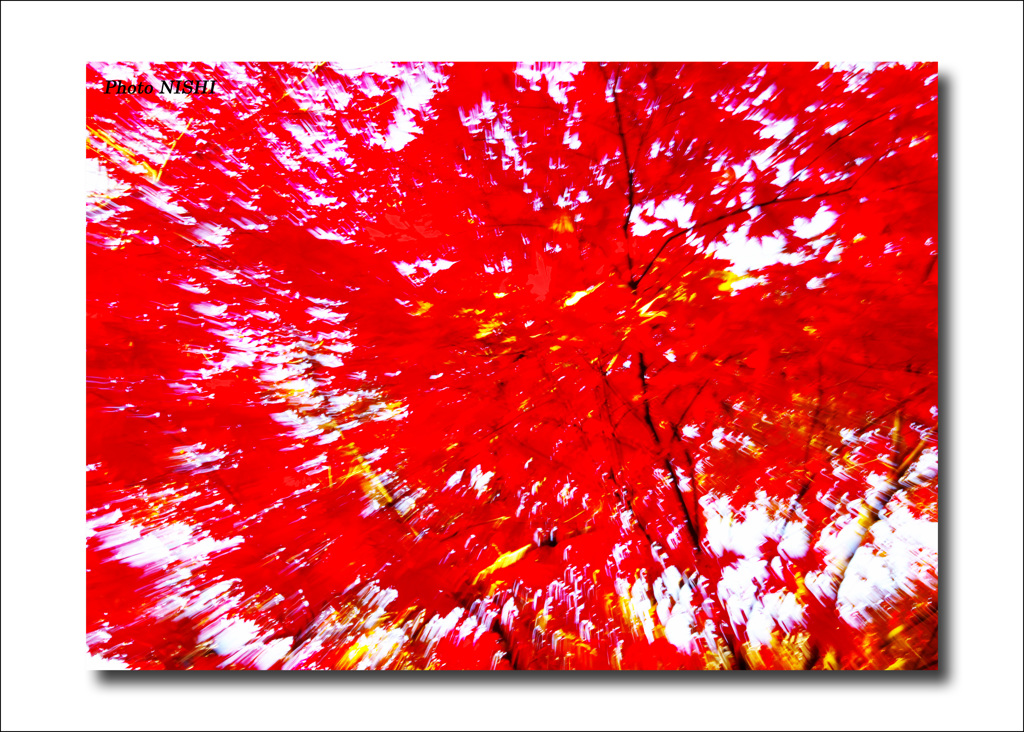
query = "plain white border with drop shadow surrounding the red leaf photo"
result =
(2, 2, 1024, 730)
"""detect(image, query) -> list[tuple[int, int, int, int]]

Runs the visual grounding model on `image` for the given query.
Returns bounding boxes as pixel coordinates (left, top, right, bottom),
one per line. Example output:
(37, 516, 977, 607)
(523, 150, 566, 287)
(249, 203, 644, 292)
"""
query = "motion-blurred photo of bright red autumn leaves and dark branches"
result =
(87, 63, 938, 669)
